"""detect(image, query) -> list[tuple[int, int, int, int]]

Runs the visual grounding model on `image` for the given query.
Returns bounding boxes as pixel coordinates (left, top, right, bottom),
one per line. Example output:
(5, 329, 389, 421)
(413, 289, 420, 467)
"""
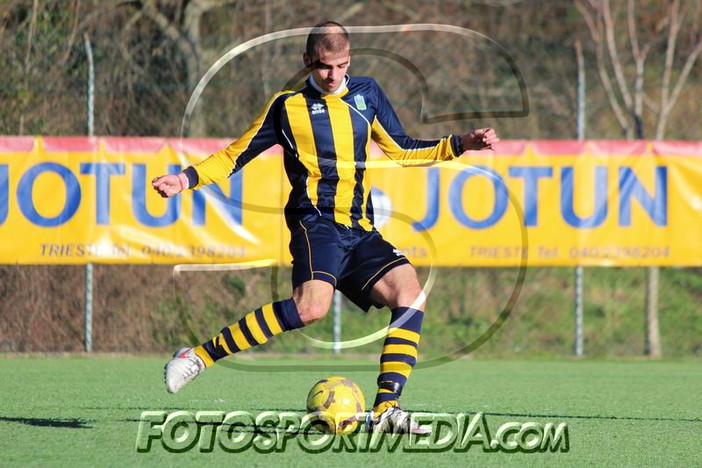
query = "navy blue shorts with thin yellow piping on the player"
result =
(288, 215, 410, 312)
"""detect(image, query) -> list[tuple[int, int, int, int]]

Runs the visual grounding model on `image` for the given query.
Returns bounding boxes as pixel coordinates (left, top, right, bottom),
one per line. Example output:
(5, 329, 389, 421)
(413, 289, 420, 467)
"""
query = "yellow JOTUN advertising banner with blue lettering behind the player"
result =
(0, 137, 702, 266)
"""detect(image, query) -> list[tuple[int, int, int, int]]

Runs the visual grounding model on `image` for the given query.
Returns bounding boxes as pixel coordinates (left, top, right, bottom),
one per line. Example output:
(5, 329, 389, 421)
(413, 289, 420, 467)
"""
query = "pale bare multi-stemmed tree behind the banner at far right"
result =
(576, 0, 702, 357)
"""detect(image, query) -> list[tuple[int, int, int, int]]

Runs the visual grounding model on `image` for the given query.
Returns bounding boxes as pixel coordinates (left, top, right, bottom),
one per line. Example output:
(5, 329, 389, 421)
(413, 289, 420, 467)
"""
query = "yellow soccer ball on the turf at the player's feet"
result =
(307, 376, 366, 434)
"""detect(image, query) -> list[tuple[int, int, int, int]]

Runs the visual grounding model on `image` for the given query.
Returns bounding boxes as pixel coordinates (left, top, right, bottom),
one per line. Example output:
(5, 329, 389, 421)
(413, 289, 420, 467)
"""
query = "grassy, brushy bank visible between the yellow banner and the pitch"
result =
(0, 265, 702, 358)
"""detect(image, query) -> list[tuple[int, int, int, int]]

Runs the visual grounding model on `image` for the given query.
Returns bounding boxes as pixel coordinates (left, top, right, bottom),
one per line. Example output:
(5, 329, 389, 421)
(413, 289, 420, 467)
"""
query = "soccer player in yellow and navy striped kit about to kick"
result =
(152, 21, 499, 433)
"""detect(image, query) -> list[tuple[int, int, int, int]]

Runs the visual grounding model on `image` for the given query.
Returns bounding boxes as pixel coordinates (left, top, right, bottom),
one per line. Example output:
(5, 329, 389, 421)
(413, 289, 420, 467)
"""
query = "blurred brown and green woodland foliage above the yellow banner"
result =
(0, 0, 702, 140)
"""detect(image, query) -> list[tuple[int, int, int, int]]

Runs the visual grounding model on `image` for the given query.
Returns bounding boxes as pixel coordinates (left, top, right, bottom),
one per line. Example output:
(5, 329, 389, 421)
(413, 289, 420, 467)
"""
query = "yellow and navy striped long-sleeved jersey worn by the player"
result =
(185, 76, 462, 231)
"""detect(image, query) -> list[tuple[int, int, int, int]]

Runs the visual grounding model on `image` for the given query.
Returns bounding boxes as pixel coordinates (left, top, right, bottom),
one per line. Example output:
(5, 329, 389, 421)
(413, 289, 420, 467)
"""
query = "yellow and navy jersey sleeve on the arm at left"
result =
(183, 93, 282, 189)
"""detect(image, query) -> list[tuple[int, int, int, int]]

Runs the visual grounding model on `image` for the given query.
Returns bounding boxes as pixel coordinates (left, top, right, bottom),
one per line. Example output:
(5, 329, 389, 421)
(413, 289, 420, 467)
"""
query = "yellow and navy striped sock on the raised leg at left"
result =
(195, 299, 305, 367)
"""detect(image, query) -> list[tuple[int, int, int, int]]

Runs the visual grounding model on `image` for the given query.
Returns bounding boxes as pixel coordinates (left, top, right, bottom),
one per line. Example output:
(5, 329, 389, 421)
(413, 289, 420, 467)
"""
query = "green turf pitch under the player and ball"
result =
(0, 356, 702, 466)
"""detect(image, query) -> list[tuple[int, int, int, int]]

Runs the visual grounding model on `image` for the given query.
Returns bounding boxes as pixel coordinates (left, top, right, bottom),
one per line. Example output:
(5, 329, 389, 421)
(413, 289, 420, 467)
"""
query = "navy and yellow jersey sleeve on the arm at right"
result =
(371, 83, 463, 166)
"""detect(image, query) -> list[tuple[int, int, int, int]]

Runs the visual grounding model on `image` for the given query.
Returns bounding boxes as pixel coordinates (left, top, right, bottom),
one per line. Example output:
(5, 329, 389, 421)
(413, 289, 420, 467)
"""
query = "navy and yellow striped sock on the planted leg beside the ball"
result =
(373, 307, 424, 416)
